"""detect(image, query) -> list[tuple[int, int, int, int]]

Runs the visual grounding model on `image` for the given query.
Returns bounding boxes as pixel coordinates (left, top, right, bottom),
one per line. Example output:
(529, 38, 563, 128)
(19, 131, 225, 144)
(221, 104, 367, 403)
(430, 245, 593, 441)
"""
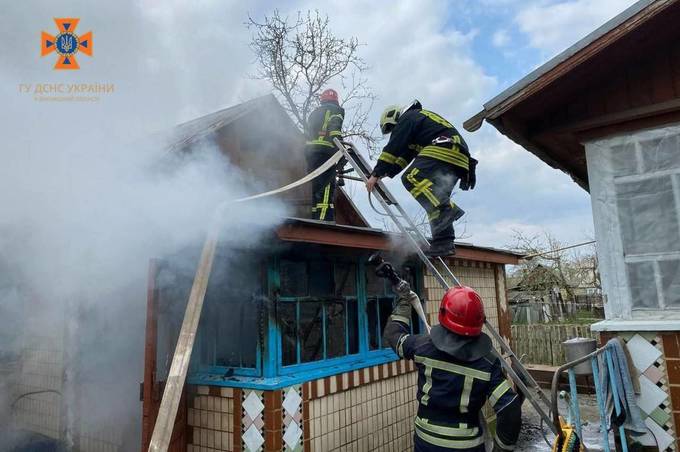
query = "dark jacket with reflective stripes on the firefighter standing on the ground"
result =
(384, 290, 522, 450)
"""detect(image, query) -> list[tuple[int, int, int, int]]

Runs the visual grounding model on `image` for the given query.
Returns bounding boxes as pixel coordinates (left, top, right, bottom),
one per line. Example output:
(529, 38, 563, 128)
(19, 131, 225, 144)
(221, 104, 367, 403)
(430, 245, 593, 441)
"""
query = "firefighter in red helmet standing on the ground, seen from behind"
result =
(376, 263, 522, 452)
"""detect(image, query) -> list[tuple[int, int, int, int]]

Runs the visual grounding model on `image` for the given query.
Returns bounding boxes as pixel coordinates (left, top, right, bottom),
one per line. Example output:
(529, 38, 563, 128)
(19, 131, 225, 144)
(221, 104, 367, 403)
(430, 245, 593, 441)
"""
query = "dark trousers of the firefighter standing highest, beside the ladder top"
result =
(305, 145, 337, 221)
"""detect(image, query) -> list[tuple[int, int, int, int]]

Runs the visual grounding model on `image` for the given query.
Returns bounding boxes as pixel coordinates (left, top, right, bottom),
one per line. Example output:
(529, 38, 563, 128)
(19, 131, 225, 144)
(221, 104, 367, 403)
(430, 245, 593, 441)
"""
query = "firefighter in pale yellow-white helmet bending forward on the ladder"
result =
(366, 100, 477, 256)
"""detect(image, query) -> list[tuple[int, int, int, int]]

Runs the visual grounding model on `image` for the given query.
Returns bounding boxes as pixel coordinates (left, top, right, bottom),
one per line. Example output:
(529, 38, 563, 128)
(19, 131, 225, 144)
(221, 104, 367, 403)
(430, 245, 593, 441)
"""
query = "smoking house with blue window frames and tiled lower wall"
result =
(142, 96, 518, 452)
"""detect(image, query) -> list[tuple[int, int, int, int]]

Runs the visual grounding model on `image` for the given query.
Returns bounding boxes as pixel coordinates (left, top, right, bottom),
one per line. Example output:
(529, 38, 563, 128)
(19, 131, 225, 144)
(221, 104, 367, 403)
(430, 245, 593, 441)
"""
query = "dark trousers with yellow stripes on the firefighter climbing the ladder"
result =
(401, 157, 464, 241)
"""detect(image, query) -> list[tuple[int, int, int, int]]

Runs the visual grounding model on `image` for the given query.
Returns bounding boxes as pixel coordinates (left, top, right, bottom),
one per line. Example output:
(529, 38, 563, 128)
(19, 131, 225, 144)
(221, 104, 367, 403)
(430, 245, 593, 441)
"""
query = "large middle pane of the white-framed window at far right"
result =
(616, 177, 680, 255)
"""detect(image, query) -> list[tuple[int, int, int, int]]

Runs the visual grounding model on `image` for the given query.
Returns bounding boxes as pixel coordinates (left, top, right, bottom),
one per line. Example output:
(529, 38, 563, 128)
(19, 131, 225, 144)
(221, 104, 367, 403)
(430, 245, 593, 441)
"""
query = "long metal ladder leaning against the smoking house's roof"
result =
(333, 138, 558, 435)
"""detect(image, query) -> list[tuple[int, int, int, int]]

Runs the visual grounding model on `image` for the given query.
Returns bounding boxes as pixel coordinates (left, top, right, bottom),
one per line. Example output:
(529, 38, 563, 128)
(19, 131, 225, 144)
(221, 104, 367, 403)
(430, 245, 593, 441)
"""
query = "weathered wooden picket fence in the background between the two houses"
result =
(511, 324, 599, 366)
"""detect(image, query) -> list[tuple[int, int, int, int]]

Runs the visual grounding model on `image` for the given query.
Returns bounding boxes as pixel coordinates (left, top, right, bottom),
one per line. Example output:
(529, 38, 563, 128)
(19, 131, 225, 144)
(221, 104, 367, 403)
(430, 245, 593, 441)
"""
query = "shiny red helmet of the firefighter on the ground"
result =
(439, 286, 486, 336)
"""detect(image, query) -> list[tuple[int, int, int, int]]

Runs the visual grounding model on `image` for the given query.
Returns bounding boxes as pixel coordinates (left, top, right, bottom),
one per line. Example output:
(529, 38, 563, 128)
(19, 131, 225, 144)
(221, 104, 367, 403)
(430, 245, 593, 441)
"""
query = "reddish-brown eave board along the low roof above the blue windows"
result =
(276, 218, 522, 265)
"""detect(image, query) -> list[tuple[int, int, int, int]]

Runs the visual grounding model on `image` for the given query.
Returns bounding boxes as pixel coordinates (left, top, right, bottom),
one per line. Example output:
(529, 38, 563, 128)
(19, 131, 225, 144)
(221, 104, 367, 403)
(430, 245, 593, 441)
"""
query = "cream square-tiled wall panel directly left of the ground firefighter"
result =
(304, 370, 417, 452)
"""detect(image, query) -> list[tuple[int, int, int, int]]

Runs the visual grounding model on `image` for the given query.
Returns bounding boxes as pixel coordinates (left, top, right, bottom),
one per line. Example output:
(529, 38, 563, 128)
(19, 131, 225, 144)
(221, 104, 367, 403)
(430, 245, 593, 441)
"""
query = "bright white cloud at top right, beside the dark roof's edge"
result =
(515, 0, 635, 55)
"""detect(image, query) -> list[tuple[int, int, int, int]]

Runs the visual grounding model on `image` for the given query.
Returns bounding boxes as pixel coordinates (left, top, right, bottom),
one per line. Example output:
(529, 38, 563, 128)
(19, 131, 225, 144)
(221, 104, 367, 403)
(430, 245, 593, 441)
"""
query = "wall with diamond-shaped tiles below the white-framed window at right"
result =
(602, 332, 680, 452)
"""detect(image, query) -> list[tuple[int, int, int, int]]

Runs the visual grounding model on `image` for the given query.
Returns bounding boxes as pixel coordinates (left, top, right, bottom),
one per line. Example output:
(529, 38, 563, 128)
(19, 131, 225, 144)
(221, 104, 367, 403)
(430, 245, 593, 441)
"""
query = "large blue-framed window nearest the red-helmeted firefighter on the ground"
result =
(270, 249, 420, 376)
